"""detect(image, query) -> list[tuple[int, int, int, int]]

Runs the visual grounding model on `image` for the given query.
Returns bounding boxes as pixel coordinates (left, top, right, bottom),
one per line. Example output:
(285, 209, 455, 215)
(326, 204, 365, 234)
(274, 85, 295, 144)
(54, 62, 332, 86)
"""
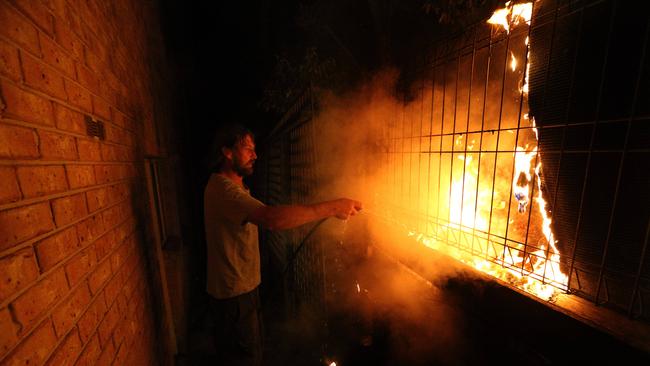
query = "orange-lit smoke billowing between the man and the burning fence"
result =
(294, 70, 480, 365)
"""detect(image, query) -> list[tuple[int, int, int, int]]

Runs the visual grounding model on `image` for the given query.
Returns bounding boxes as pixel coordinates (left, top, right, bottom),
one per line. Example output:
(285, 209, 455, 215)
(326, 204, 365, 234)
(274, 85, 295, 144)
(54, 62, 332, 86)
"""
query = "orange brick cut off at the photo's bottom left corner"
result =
(5, 319, 56, 366)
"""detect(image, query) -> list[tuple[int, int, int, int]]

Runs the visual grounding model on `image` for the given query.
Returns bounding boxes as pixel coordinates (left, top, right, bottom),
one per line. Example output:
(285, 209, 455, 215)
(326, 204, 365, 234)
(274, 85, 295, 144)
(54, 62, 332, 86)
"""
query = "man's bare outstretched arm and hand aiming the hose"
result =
(246, 198, 362, 230)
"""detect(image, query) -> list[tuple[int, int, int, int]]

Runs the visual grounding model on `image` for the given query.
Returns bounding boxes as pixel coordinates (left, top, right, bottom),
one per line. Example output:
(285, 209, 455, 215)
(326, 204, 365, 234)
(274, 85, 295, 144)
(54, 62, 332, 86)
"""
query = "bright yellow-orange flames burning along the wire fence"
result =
(382, 2, 568, 299)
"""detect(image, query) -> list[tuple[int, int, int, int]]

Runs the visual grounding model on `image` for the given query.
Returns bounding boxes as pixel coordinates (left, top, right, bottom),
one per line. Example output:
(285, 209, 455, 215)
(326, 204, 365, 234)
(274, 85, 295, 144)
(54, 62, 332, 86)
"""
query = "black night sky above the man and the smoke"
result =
(161, 0, 498, 135)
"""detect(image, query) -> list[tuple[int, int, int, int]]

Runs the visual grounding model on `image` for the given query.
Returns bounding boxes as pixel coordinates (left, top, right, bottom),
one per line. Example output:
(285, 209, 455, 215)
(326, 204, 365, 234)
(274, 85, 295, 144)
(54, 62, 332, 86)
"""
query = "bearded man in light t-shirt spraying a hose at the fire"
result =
(204, 125, 362, 365)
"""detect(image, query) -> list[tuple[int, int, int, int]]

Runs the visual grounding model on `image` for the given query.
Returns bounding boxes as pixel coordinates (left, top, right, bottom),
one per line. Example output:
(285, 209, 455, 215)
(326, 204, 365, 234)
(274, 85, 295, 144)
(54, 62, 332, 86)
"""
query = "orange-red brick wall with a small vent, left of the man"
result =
(0, 0, 175, 365)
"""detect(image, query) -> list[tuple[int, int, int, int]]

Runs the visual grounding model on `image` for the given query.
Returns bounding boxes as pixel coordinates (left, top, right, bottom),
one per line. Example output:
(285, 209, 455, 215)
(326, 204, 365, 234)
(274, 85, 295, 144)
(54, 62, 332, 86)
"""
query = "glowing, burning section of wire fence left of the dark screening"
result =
(379, 3, 567, 299)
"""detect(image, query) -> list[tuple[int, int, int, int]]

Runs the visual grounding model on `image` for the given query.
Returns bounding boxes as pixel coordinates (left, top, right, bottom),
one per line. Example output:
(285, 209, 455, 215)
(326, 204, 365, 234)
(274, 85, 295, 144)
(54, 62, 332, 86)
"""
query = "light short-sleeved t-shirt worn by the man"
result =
(203, 174, 264, 299)
